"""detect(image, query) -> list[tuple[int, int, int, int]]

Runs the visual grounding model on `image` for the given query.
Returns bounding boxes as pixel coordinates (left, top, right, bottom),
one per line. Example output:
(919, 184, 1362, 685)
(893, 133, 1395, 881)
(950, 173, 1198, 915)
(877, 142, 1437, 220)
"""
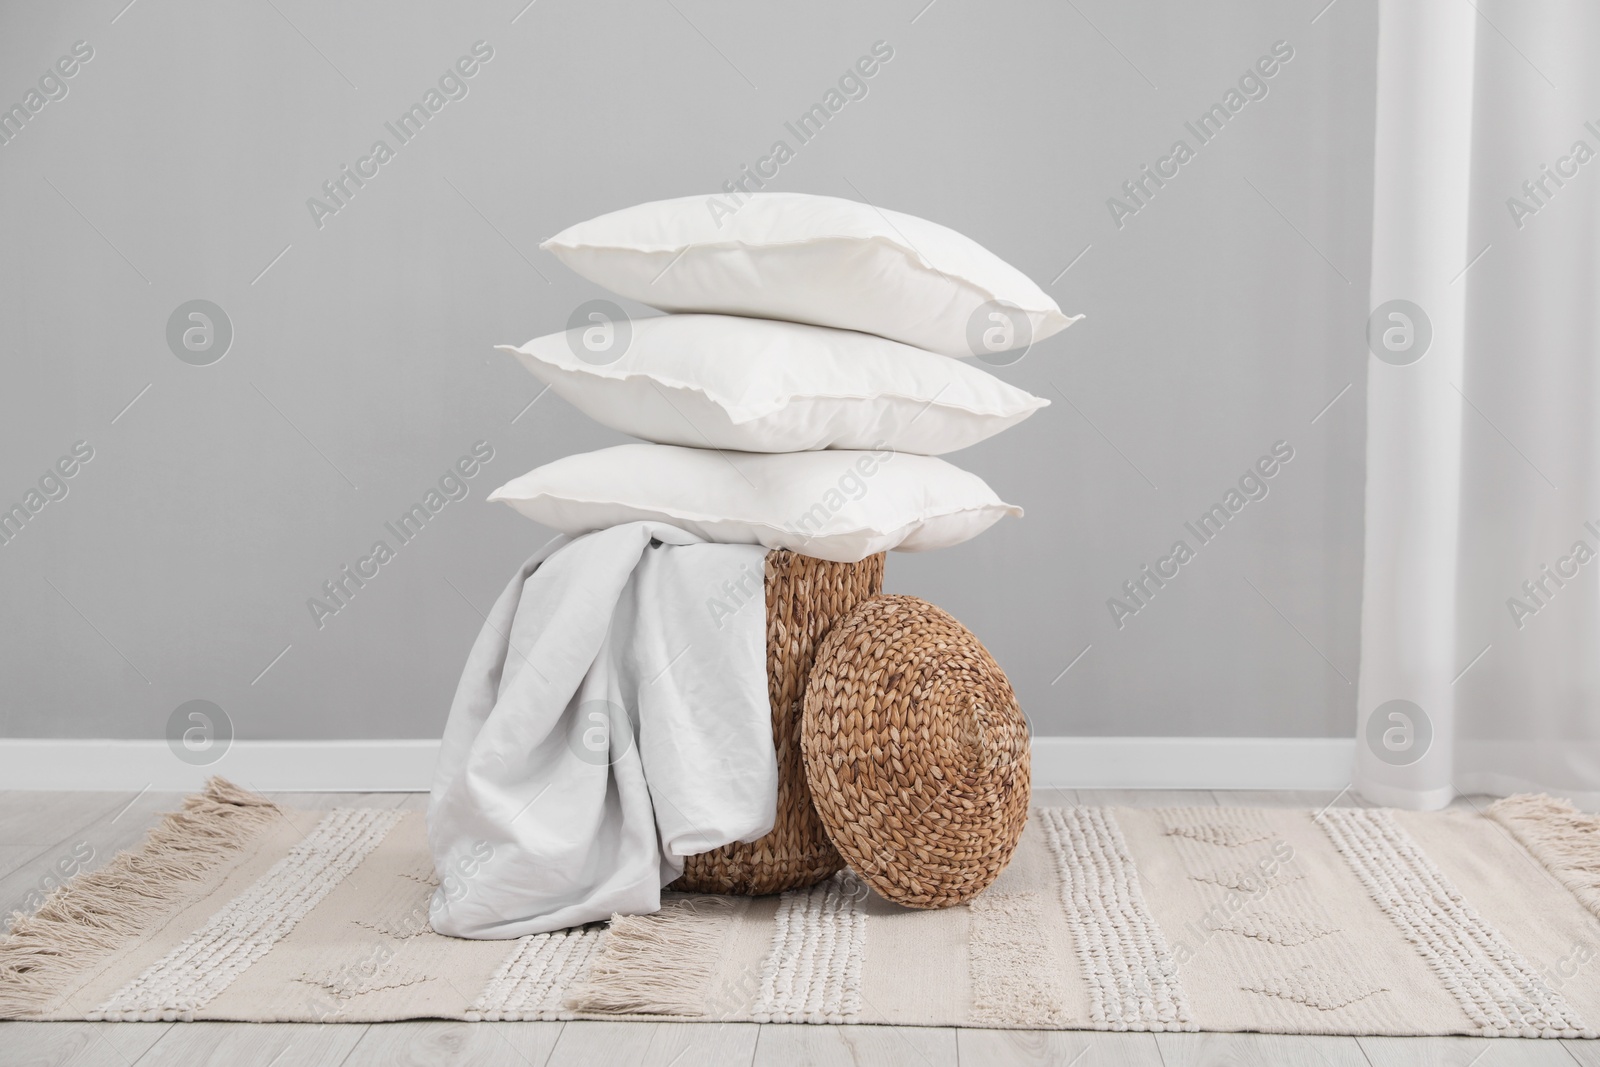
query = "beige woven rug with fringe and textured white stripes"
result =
(0, 781, 1600, 1037)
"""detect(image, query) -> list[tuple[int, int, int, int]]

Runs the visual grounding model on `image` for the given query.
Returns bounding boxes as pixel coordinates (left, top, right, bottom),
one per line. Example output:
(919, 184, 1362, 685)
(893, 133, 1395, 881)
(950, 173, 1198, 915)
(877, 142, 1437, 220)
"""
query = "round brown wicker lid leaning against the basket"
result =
(800, 595, 1029, 909)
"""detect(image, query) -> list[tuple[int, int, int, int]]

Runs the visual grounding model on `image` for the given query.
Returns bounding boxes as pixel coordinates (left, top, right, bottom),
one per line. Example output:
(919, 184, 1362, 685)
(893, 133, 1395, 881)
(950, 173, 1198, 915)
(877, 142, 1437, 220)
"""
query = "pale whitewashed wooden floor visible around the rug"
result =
(0, 790, 1600, 1067)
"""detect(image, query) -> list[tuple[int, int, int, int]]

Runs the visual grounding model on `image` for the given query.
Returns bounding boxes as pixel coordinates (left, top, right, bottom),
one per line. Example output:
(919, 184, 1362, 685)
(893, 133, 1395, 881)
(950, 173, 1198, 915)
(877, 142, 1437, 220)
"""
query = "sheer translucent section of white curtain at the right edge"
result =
(1454, 0, 1600, 808)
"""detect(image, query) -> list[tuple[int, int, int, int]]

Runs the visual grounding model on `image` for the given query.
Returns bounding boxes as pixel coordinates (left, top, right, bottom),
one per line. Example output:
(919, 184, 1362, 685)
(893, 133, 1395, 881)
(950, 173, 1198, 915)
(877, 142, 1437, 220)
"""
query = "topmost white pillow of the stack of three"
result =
(539, 192, 1082, 357)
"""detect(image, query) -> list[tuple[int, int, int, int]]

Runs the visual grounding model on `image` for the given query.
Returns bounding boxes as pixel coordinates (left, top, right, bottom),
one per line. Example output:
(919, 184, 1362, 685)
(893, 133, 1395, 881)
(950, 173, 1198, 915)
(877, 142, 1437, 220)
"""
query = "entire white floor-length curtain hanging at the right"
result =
(1355, 0, 1600, 808)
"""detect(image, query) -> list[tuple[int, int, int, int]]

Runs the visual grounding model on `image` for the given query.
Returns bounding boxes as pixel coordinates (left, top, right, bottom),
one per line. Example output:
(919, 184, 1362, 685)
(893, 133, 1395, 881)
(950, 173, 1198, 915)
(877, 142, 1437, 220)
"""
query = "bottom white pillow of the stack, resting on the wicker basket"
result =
(490, 445, 1022, 563)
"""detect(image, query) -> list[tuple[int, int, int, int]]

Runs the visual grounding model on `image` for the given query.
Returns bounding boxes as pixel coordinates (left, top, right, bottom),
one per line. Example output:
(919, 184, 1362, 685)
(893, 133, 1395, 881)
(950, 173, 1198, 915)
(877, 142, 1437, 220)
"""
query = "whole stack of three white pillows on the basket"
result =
(490, 194, 1077, 561)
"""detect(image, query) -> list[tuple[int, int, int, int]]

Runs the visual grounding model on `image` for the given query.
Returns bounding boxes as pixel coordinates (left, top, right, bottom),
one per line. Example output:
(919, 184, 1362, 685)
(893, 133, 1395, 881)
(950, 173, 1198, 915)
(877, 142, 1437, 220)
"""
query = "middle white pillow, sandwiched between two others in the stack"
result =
(499, 315, 1050, 456)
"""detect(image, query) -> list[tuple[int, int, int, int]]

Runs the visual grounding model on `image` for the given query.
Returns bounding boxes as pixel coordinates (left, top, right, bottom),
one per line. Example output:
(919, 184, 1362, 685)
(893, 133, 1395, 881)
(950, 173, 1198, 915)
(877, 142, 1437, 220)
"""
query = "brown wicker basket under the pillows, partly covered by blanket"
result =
(667, 550, 883, 896)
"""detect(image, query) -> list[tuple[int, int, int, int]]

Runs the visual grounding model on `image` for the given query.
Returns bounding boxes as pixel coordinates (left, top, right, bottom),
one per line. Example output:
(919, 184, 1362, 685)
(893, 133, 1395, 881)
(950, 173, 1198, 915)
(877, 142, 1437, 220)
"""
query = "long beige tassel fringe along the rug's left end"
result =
(0, 777, 278, 1019)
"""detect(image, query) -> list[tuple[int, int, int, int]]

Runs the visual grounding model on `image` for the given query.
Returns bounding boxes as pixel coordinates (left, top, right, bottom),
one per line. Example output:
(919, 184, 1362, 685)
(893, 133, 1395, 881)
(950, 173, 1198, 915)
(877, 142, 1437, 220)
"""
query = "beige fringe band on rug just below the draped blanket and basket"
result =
(565, 897, 736, 1016)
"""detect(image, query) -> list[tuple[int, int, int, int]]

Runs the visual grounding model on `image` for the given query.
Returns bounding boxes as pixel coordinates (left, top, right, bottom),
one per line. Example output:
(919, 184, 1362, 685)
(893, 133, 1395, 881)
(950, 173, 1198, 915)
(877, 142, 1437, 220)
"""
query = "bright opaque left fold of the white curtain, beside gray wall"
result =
(1355, 0, 1475, 808)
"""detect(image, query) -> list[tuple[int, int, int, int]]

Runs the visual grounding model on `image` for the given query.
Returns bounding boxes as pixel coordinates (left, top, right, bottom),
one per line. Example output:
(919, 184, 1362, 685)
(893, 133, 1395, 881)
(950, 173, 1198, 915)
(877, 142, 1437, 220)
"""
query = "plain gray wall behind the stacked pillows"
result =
(0, 0, 1376, 737)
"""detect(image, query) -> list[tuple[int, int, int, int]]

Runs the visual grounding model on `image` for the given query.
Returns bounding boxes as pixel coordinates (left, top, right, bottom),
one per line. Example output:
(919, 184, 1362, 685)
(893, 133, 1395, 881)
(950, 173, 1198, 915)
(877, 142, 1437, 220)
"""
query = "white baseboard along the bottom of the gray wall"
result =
(0, 737, 1355, 793)
